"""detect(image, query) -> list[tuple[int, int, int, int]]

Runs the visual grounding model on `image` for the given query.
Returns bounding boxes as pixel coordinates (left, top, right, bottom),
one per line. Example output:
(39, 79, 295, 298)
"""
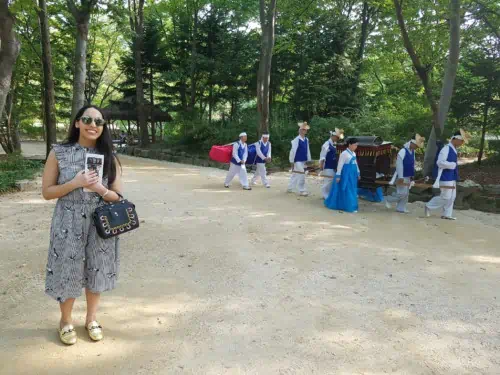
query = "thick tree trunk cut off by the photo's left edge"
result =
(0, 0, 21, 127)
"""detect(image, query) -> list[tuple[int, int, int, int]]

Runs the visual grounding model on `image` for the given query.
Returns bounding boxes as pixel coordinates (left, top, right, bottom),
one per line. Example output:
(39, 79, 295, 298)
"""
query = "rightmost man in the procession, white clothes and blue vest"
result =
(425, 129, 470, 220)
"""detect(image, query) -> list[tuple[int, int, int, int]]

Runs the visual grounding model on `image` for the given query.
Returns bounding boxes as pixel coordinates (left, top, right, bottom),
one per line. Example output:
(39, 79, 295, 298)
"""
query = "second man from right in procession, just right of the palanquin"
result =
(385, 134, 425, 214)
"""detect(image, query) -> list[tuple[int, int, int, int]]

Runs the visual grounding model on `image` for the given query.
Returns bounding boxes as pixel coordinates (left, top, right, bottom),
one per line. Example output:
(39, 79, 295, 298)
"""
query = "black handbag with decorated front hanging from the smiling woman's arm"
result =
(93, 195, 139, 239)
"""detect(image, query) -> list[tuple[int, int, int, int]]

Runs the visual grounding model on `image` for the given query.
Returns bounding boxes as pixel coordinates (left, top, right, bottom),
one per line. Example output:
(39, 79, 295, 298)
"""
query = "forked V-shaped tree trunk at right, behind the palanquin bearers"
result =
(393, 0, 460, 176)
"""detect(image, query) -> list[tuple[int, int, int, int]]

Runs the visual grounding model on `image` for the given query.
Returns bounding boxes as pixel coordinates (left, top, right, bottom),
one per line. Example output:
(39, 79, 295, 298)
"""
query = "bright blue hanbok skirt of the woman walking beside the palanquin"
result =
(325, 162, 358, 212)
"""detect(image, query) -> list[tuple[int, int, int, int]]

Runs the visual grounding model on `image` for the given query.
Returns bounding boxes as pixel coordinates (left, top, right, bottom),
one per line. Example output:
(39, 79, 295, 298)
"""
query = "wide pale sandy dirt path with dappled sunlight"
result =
(0, 151, 500, 375)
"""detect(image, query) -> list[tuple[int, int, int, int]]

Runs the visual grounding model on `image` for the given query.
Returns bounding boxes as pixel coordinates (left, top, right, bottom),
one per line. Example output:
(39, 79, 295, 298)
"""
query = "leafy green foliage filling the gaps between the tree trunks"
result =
(6, 0, 500, 166)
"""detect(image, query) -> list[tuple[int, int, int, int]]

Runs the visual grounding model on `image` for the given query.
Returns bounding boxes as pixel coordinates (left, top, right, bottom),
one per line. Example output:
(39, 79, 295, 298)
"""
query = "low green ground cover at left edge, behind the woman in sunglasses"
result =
(0, 154, 43, 194)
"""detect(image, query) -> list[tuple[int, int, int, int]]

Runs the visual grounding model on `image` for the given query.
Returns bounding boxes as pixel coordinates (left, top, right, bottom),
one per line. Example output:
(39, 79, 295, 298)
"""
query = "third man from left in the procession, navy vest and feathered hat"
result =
(287, 122, 312, 197)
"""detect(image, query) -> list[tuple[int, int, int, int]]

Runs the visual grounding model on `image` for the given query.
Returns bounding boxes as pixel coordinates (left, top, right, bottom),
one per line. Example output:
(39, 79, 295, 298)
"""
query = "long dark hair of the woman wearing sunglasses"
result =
(64, 105, 120, 185)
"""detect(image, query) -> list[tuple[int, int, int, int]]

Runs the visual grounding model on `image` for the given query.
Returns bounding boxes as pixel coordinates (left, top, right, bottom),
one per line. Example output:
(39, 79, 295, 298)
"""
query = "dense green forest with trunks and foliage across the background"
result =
(0, 0, 500, 173)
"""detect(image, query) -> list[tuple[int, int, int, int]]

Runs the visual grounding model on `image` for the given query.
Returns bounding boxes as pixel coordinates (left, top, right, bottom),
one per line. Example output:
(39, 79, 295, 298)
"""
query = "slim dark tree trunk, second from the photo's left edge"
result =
(38, 0, 57, 156)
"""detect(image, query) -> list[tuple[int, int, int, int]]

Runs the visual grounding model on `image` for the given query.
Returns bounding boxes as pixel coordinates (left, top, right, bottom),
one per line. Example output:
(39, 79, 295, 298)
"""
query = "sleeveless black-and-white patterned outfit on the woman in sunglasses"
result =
(45, 144, 119, 302)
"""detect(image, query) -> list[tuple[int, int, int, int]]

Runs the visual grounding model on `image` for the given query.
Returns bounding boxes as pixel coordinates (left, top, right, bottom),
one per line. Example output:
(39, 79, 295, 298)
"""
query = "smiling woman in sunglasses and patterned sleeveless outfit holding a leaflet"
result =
(42, 106, 122, 345)
